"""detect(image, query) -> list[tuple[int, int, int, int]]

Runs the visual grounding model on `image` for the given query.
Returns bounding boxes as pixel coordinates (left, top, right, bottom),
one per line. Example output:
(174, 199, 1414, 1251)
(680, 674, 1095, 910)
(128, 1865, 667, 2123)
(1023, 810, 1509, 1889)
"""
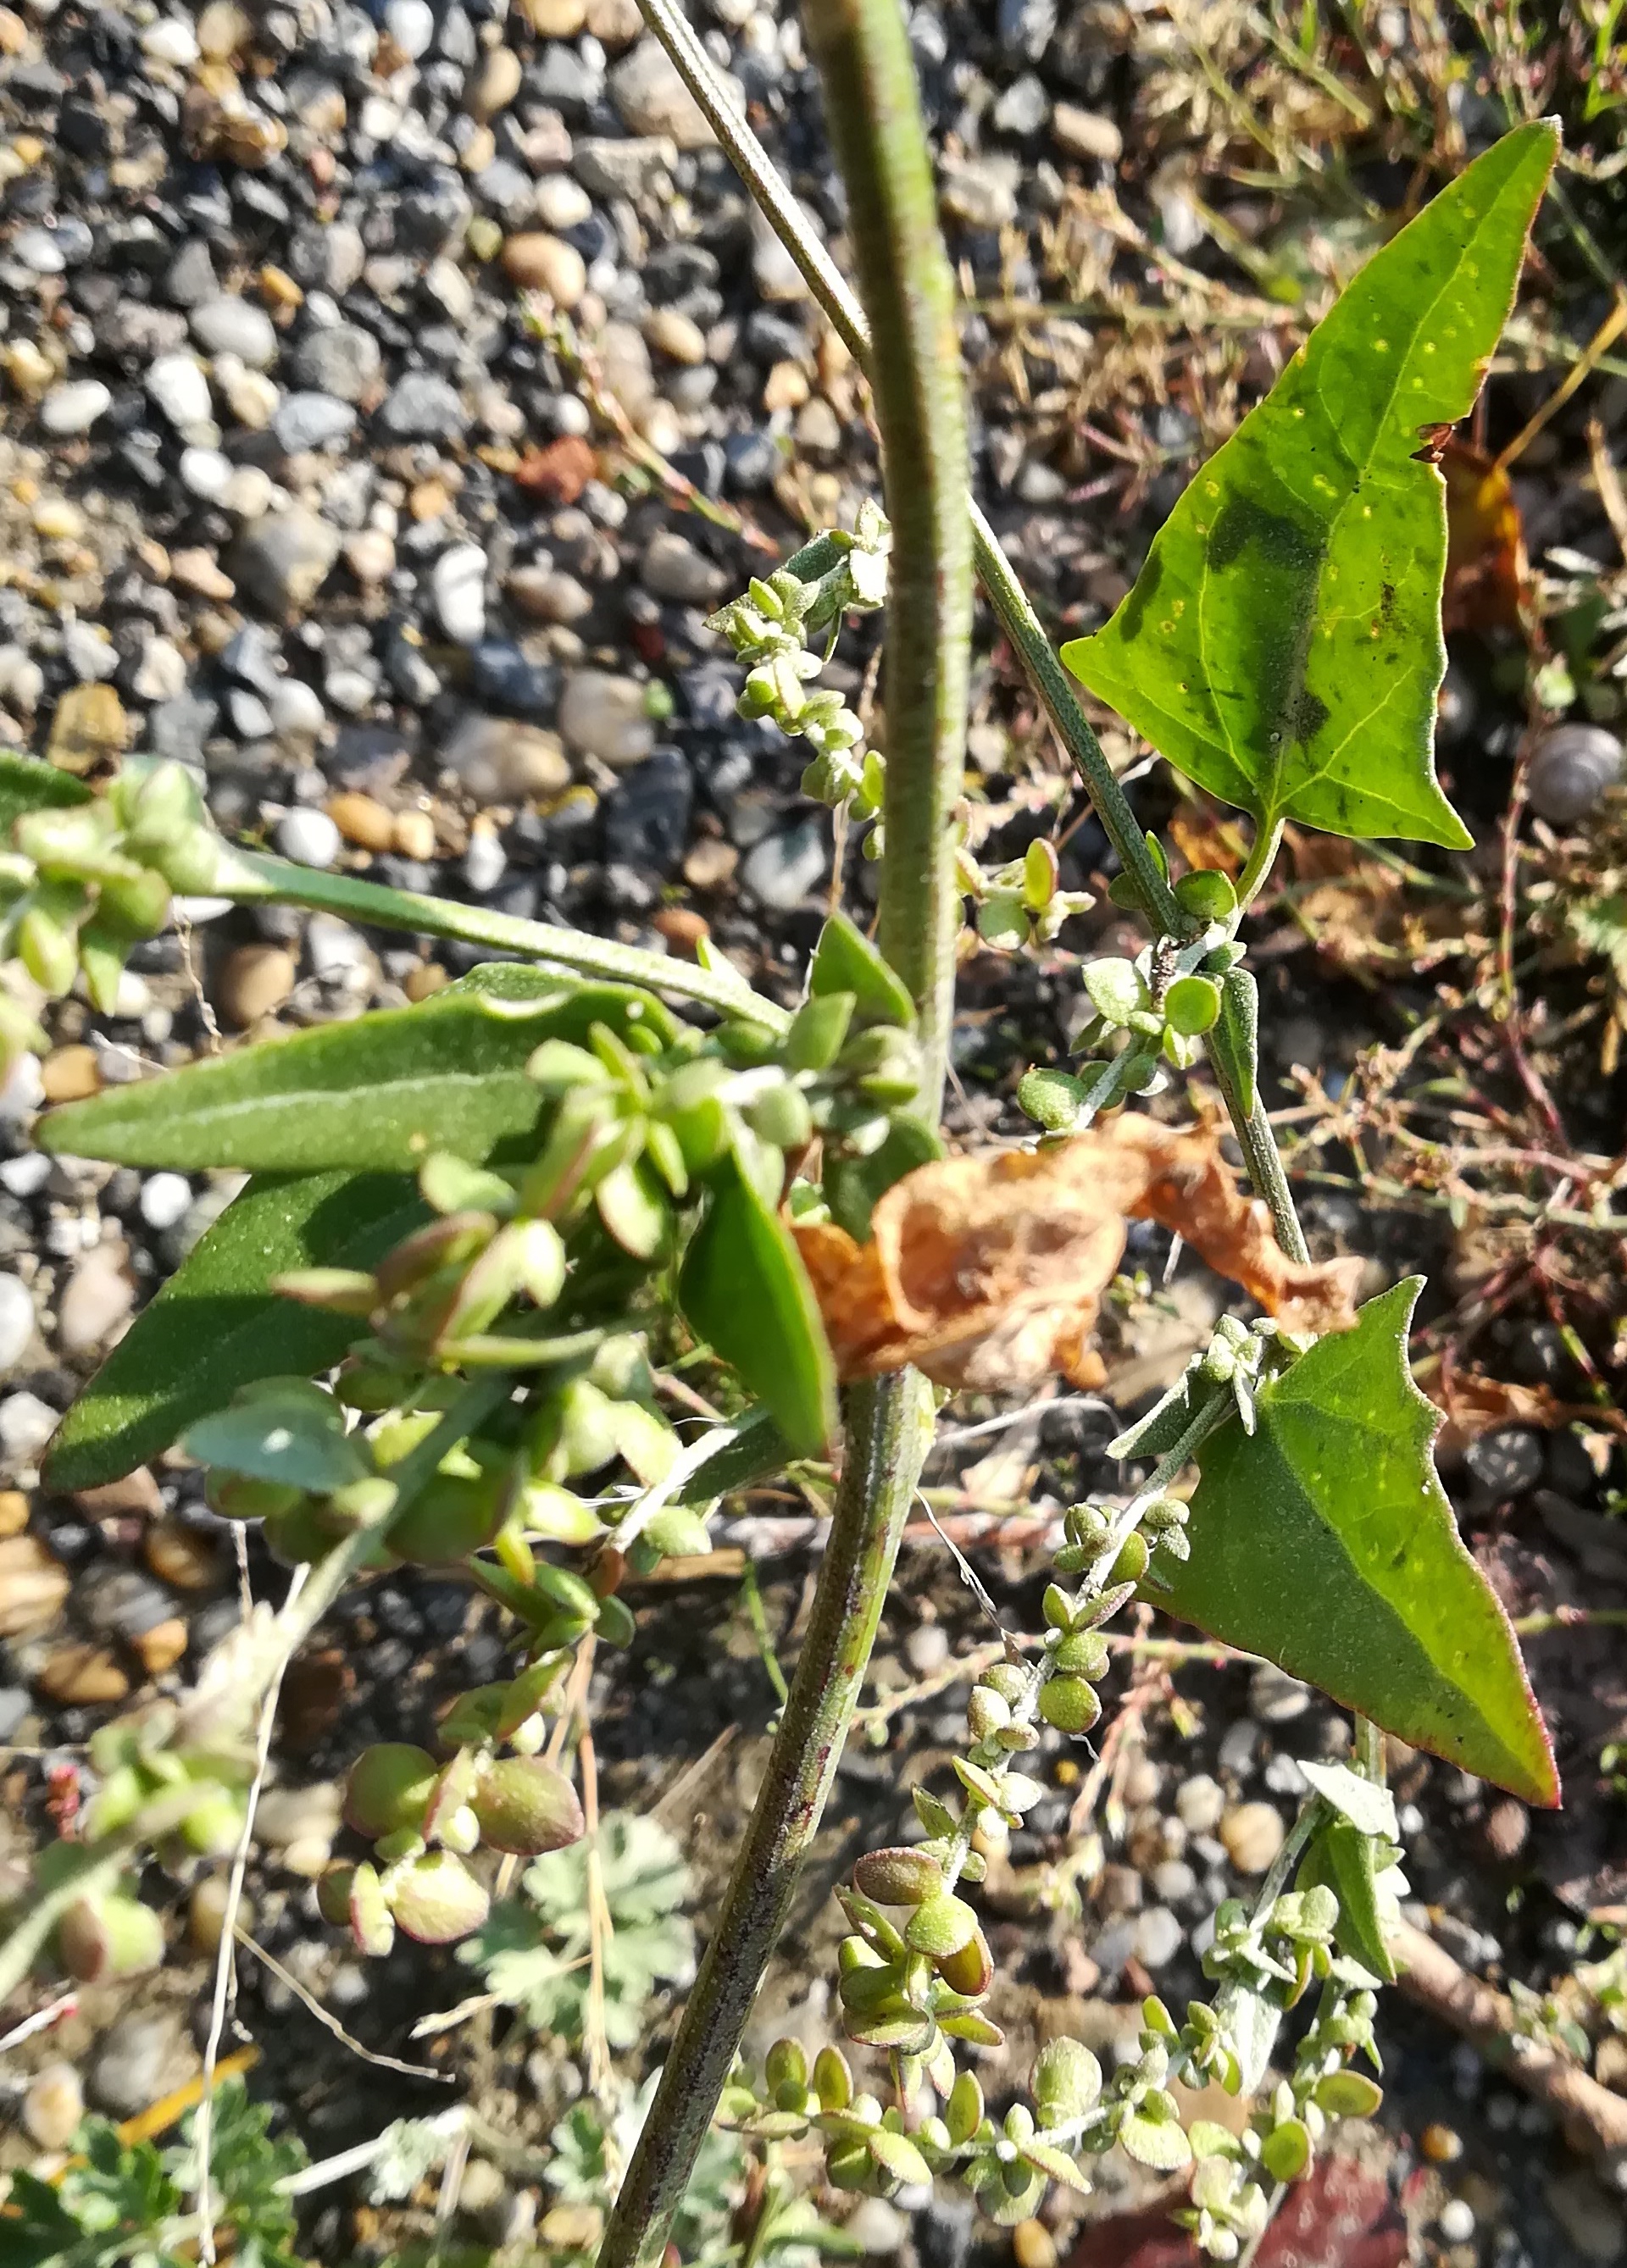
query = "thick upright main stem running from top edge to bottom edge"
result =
(599, 0, 971, 2268)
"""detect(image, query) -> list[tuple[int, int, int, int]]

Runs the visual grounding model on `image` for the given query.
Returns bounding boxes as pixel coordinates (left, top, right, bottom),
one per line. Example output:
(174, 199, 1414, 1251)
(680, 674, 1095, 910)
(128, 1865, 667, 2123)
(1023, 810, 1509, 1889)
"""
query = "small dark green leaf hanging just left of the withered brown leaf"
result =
(679, 1152, 835, 1456)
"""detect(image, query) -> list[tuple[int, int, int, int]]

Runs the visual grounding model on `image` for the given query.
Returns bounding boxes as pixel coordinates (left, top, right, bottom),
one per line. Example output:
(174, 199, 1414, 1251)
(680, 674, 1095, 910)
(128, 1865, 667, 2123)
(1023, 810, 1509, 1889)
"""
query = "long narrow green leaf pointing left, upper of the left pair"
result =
(39, 962, 676, 1173)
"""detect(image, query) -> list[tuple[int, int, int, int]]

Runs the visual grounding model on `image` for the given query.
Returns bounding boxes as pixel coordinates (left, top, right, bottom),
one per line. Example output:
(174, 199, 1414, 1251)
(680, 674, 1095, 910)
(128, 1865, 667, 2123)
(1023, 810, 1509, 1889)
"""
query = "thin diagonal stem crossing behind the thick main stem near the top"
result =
(637, 0, 1191, 937)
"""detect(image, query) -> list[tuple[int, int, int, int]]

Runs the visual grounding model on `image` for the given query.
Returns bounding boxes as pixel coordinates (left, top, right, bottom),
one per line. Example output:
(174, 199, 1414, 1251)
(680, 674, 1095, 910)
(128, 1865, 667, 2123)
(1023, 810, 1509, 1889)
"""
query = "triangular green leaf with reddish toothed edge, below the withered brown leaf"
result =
(1151, 1277, 1559, 1803)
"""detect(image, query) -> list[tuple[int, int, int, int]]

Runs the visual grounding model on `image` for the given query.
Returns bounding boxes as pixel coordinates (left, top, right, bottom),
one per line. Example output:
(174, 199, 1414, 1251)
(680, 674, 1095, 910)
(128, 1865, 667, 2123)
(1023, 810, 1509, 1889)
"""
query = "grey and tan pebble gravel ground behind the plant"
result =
(0, 0, 1627, 2268)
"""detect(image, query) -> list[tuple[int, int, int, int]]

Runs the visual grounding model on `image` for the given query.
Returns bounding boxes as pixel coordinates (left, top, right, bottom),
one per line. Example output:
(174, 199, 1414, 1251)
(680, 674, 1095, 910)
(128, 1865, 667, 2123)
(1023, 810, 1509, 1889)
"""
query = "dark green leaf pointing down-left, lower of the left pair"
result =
(46, 1173, 426, 1490)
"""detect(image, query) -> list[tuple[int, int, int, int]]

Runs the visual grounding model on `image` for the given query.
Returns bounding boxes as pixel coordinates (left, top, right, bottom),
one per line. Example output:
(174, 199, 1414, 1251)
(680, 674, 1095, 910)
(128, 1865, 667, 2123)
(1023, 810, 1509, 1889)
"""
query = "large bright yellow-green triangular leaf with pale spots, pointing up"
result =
(1062, 123, 1559, 851)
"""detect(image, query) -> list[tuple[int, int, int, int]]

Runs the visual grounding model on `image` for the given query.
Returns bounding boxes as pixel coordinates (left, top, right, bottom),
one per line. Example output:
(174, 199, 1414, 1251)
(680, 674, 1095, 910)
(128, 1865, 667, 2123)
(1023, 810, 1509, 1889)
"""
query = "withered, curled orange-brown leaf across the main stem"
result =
(794, 1116, 1362, 1393)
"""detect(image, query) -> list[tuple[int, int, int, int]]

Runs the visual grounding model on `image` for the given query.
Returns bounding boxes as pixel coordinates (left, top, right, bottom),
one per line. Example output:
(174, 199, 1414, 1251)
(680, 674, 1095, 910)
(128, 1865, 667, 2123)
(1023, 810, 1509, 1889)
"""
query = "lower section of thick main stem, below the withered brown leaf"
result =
(597, 1370, 933, 2268)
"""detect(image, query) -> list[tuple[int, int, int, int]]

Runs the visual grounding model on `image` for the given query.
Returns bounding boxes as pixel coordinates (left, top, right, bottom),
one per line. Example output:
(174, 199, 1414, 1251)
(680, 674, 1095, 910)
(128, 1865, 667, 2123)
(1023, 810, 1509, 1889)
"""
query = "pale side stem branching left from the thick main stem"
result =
(220, 851, 790, 1032)
